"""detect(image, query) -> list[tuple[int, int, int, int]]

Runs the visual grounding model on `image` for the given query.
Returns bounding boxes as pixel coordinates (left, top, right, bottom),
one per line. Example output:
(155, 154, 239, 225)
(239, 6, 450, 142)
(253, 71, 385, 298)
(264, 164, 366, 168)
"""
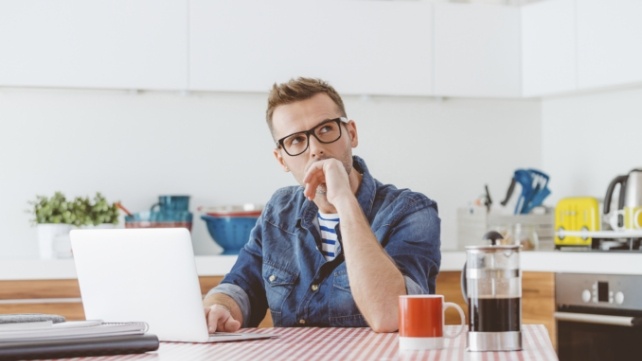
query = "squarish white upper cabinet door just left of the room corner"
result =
(434, 3, 521, 97)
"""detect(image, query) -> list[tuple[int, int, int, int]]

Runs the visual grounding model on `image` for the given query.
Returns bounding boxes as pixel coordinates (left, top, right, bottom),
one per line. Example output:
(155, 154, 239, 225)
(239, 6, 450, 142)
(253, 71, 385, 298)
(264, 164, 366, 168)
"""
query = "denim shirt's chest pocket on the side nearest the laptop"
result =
(263, 265, 297, 327)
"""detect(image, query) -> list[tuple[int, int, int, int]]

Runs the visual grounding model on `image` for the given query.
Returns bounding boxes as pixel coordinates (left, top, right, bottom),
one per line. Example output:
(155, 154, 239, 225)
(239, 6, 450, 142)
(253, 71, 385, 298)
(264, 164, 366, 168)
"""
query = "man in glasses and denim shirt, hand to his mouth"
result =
(204, 78, 441, 332)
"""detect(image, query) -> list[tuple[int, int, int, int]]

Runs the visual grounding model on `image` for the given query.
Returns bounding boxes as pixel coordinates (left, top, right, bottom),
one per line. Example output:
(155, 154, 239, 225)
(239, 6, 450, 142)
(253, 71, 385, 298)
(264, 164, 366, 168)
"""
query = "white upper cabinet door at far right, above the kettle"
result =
(577, 0, 642, 88)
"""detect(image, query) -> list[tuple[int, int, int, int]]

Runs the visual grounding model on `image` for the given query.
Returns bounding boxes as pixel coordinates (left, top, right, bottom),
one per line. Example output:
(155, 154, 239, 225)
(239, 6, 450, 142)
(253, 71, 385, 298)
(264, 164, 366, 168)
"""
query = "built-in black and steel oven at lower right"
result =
(555, 273, 642, 361)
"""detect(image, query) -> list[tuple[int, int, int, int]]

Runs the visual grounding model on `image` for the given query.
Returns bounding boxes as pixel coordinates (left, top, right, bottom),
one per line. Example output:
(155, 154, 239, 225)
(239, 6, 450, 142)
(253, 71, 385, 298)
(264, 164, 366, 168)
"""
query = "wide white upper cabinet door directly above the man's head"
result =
(189, 0, 432, 95)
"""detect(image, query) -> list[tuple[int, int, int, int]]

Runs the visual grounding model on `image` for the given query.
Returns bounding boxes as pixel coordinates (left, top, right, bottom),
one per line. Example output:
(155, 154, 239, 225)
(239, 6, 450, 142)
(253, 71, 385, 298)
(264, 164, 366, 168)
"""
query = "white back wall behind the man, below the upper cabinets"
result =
(0, 87, 540, 259)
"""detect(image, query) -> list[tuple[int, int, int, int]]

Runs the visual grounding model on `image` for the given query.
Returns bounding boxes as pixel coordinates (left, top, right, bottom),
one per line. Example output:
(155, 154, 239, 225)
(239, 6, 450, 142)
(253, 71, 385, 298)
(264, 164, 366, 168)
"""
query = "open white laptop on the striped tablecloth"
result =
(70, 228, 274, 342)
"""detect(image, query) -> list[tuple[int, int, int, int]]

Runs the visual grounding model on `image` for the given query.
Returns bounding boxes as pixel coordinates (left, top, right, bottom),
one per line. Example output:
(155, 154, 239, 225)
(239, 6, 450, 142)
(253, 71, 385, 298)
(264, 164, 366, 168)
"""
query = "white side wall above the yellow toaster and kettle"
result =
(542, 85, 642, 204)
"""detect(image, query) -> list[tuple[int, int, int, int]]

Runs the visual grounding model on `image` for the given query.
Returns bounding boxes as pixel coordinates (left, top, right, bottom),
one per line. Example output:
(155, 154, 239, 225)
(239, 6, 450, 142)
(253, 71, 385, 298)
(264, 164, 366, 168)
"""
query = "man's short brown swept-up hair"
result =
(266, 77, 346, 132)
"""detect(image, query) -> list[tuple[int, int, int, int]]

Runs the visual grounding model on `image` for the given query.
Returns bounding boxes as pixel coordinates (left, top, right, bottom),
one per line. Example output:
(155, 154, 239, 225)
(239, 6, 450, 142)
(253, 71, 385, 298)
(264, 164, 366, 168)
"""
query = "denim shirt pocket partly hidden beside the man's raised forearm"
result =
(329, 270, 368, 327)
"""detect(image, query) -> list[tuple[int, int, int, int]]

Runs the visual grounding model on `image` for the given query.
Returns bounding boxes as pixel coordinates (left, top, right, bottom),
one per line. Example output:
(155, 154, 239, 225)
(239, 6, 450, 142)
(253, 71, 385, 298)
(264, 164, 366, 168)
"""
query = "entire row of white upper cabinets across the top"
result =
(0, 0, 642, 98)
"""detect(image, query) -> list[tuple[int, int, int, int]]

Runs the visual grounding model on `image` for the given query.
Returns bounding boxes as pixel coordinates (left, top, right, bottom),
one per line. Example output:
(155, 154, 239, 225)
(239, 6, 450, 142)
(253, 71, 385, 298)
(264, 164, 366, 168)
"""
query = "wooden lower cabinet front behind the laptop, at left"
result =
(0, 276, 272, 327)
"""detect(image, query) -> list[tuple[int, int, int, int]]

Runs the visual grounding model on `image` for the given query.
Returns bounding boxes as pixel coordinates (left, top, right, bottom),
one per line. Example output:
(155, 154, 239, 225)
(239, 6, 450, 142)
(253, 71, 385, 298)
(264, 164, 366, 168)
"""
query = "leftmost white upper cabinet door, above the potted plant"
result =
(0, 0, 187, 89)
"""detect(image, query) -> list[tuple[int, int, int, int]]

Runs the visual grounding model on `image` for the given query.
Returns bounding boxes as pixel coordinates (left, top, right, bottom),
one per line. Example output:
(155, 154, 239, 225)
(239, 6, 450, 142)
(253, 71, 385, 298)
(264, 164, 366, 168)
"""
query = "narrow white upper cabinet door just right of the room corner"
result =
(522, 0, 577, 96)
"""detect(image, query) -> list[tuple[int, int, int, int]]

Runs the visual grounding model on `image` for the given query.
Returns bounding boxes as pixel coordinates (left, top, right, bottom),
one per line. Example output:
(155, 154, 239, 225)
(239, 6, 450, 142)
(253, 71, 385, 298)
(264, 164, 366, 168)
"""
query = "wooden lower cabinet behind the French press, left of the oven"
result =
(436, 271, 556, 347)
